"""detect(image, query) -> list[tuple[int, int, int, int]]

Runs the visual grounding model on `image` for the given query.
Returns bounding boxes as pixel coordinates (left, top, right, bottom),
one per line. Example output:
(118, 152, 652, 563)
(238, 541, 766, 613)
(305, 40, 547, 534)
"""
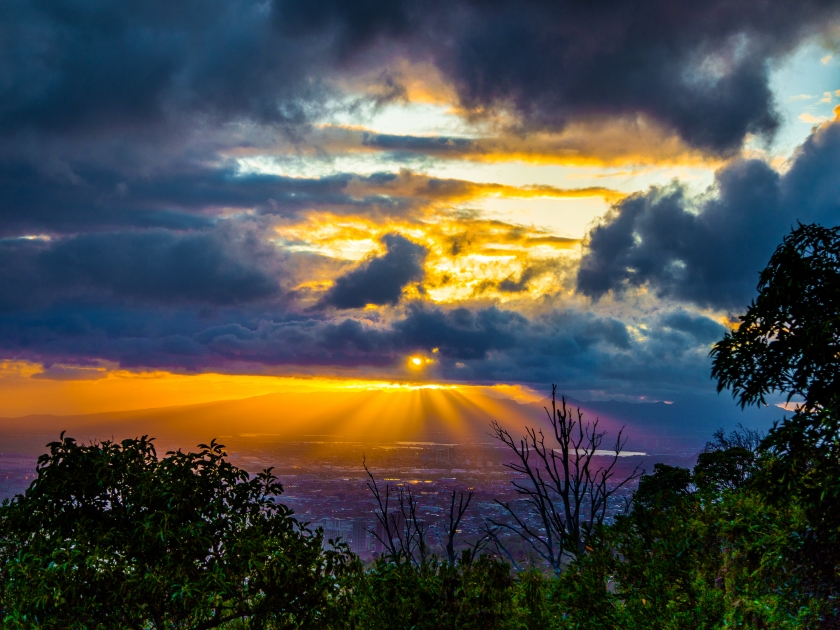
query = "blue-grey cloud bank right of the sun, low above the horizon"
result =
(392, 308, 714, 395)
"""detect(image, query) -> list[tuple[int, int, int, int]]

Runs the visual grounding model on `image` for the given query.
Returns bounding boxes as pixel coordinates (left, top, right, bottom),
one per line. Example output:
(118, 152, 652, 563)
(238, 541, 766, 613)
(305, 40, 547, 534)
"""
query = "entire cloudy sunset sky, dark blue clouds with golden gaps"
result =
(0, 0, 840, 415)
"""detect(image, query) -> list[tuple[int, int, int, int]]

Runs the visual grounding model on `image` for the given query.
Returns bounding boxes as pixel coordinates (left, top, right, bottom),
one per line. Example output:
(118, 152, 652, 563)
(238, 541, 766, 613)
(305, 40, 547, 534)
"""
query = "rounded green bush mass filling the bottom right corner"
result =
(561, 453, 837, 630)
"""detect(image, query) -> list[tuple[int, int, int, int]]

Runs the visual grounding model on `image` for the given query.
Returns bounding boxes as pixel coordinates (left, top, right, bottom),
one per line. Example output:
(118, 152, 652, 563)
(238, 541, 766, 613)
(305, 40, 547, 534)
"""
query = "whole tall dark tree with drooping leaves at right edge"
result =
(712, 225, 840, 599)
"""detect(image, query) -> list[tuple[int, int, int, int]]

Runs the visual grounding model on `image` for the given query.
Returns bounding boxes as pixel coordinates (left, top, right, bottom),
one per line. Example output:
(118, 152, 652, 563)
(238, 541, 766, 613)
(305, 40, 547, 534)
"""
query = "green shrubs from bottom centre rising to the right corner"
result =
(346, 430, 840, 630)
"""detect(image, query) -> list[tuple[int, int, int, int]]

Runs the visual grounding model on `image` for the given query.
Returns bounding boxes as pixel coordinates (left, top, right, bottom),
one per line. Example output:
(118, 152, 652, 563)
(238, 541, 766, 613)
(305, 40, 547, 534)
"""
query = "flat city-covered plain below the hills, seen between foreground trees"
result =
(0, 435, 697, 560)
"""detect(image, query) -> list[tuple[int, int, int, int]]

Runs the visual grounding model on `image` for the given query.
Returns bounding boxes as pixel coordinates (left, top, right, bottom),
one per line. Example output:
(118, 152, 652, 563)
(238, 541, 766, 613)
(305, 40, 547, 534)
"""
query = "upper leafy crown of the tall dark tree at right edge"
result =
(711, 225, 840, 411)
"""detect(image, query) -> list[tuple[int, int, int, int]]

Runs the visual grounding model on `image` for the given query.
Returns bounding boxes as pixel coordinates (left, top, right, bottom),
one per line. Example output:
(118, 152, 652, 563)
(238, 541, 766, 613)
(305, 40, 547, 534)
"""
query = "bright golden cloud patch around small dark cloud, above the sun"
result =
(275, 212, 580, 305)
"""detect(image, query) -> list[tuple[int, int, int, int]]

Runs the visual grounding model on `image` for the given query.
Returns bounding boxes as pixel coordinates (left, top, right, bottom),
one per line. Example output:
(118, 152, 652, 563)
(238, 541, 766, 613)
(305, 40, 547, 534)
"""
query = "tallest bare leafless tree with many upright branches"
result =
(487, 385, 642, 574)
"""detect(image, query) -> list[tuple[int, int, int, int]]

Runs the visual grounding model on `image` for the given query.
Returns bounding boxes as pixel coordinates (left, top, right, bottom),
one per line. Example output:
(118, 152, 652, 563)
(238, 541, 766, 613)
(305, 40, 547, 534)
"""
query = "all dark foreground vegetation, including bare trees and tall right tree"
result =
(0, 226, 840, 630)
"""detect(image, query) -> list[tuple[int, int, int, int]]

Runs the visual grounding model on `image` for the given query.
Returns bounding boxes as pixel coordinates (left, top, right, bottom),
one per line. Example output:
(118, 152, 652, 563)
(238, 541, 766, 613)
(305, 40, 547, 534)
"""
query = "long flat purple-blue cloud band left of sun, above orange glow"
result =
(0, 306, 396, 371)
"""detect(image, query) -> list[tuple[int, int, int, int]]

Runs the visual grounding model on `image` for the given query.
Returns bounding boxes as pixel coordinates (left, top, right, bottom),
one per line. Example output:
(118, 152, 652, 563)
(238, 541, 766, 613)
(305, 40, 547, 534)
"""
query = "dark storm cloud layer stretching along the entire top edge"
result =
(0, 0, 840, 151)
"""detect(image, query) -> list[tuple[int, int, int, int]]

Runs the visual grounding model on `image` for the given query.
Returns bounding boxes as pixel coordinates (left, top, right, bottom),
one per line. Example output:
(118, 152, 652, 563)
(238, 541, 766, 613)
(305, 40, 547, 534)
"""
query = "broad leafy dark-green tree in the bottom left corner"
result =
(0, 434, 353, 629)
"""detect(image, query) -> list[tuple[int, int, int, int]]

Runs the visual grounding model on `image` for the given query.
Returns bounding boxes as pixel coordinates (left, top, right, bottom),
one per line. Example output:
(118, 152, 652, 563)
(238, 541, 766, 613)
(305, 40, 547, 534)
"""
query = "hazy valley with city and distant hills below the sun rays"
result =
(0, 389, 781, 560)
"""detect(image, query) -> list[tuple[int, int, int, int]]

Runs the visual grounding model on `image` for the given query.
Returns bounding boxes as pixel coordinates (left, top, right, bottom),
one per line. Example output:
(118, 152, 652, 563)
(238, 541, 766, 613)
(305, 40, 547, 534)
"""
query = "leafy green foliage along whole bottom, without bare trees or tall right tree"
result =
(0, 430, 840, 630)
